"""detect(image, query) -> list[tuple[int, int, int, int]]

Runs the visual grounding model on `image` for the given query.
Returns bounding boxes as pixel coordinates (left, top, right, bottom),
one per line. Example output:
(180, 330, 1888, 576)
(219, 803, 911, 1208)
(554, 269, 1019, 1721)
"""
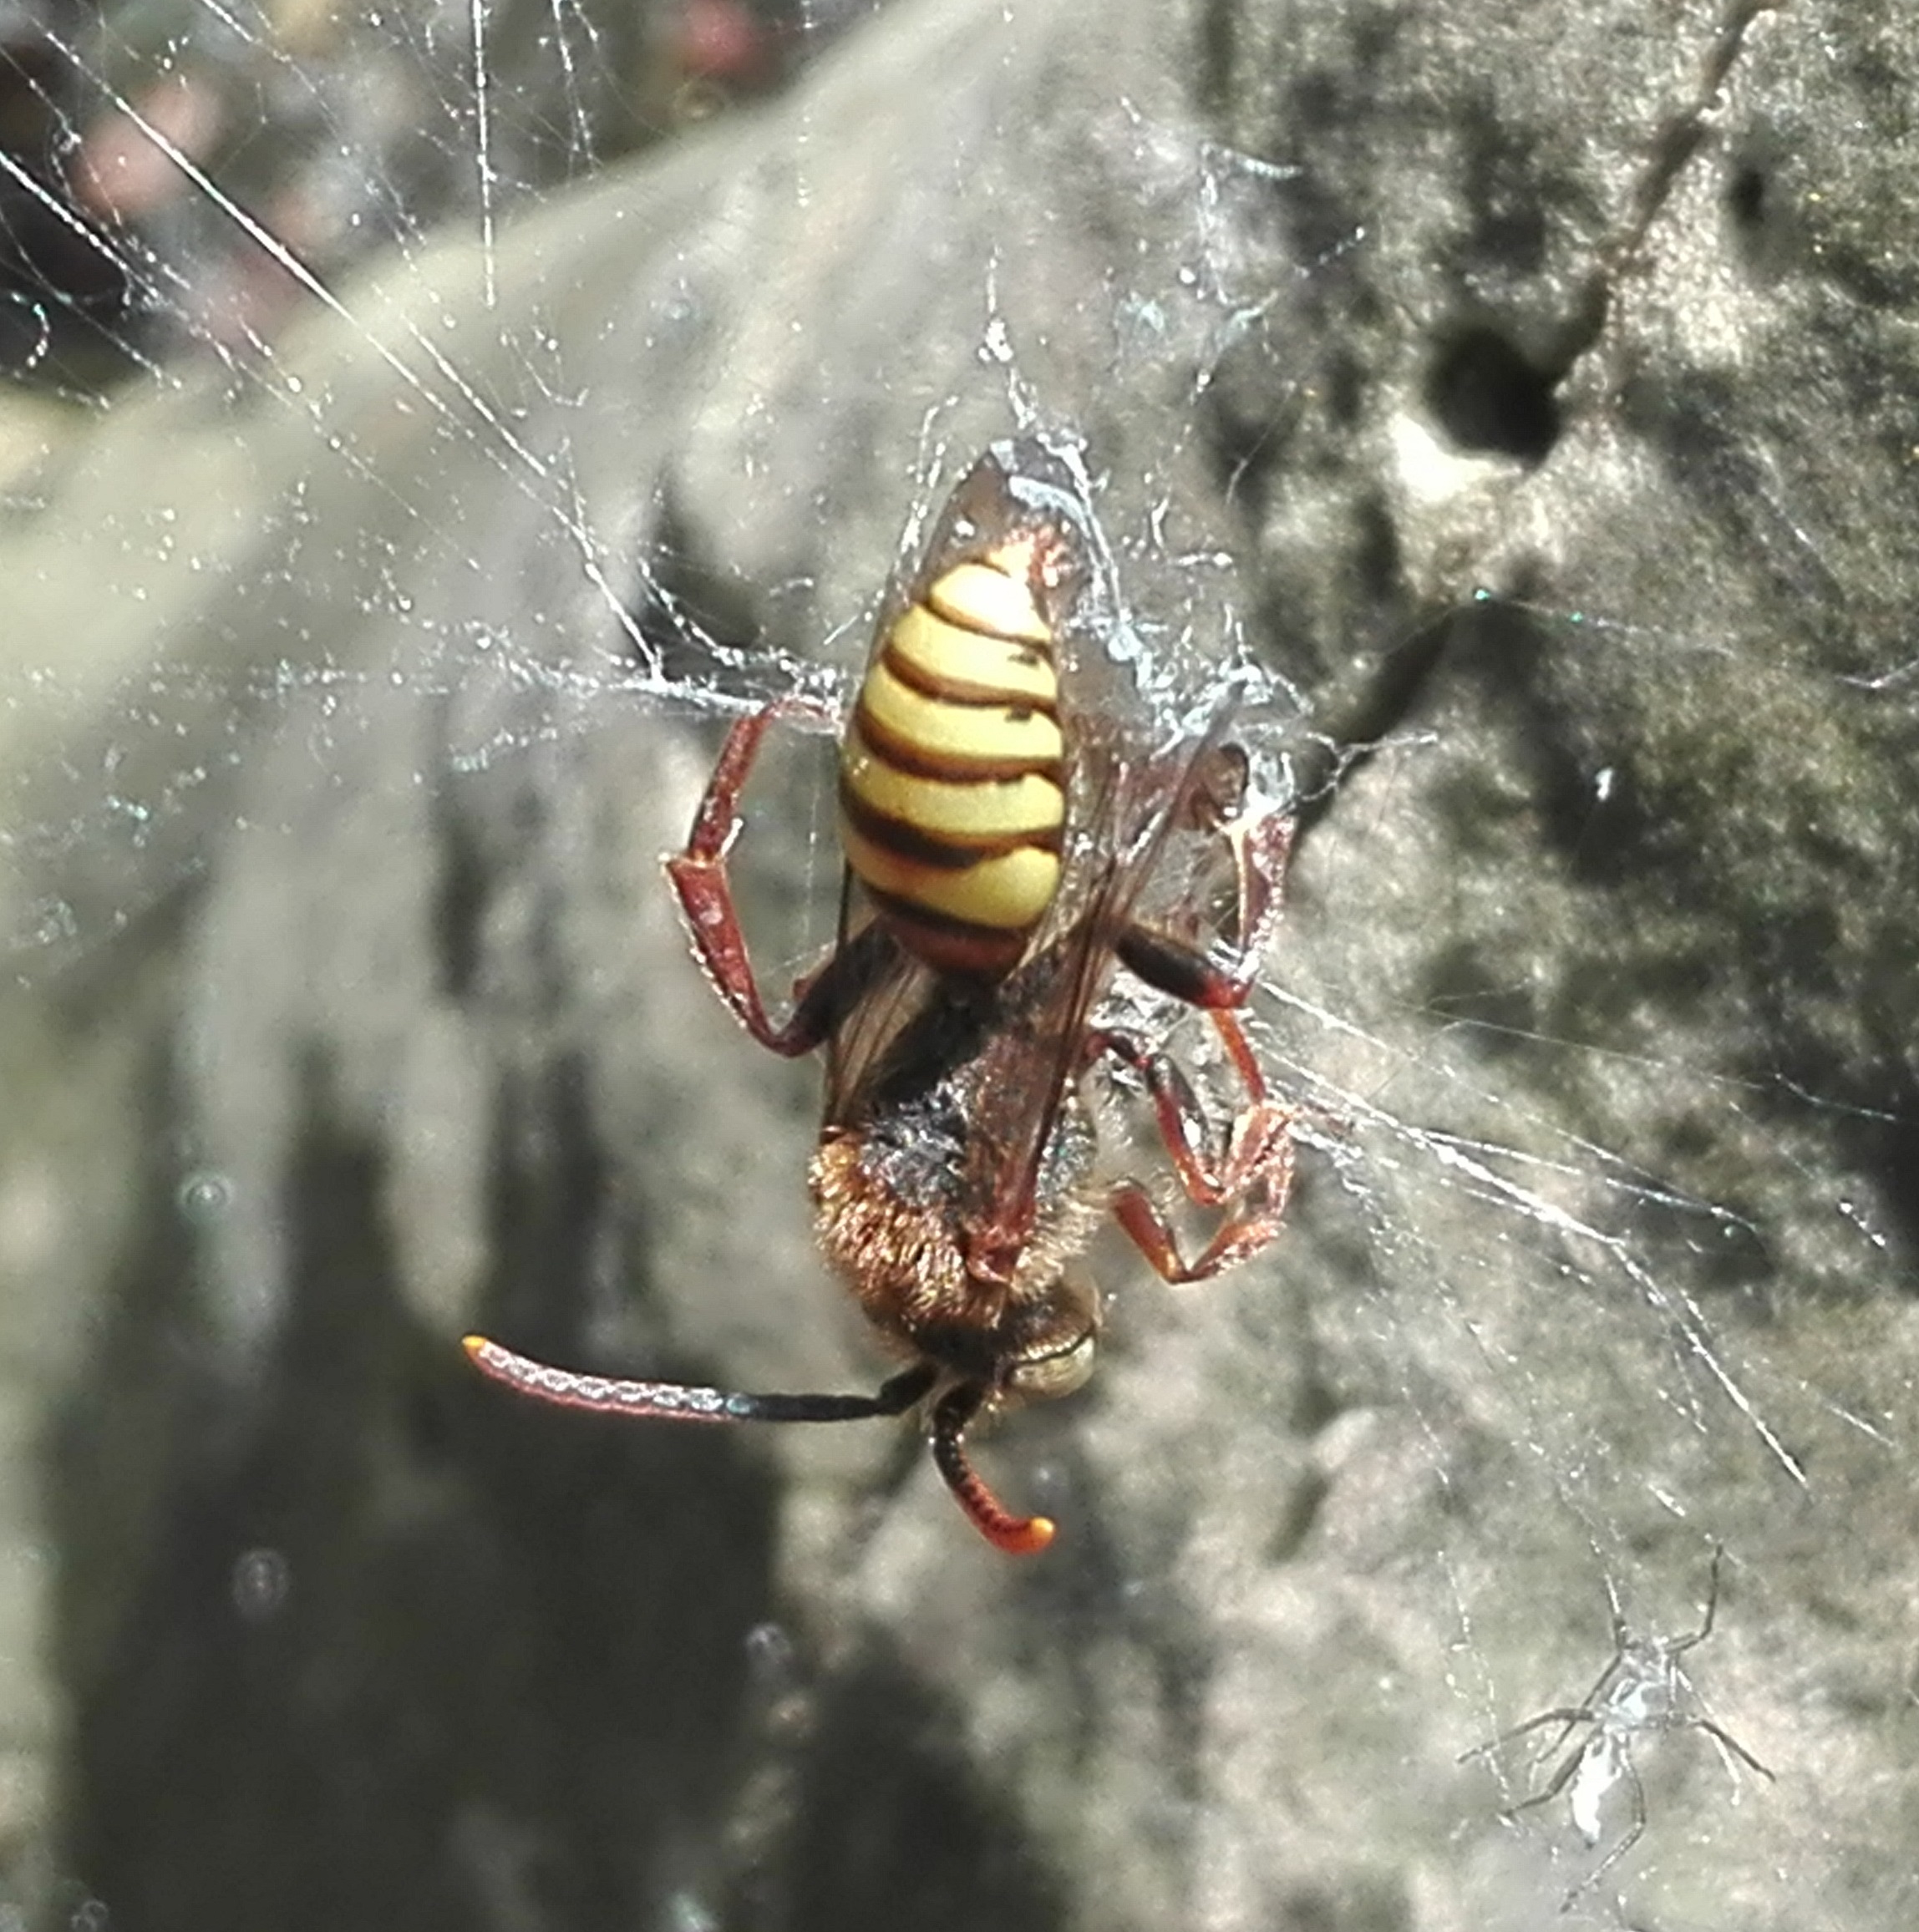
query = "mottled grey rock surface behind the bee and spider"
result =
(0, 0, 1919, 1932)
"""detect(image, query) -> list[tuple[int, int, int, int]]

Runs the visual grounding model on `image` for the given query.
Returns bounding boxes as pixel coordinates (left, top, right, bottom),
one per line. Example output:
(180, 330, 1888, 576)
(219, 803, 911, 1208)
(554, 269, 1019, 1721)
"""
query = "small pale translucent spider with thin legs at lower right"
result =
(1459, 1545, 1772, 1913)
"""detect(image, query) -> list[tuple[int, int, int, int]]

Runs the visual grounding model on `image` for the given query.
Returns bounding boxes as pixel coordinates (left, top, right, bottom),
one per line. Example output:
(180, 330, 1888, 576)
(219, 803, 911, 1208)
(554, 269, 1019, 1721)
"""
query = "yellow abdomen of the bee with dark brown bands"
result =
(839, 543, 1067, 974)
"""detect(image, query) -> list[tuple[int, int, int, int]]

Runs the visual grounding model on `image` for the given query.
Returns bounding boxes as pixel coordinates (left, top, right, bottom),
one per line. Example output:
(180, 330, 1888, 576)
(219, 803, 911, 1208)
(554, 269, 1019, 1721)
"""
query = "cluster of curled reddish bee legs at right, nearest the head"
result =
(1086, 1008, 1295, 1283)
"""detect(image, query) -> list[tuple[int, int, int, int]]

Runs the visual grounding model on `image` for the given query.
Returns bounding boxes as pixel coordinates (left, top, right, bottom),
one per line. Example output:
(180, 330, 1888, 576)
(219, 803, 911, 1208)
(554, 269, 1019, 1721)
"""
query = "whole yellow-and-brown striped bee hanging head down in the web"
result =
(465, 437, 1293, 1554)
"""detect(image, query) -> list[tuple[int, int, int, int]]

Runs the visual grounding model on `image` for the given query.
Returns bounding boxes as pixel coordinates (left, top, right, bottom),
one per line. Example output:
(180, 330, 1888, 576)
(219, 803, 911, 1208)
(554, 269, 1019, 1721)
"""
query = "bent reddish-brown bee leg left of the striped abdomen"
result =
(667, 705, 871, 1059)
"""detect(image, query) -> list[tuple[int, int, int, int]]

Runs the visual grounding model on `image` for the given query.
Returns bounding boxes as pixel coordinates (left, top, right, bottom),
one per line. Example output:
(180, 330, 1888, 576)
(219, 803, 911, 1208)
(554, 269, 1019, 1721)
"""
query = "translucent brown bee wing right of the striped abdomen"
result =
(967, 693, 1236, 1255)
